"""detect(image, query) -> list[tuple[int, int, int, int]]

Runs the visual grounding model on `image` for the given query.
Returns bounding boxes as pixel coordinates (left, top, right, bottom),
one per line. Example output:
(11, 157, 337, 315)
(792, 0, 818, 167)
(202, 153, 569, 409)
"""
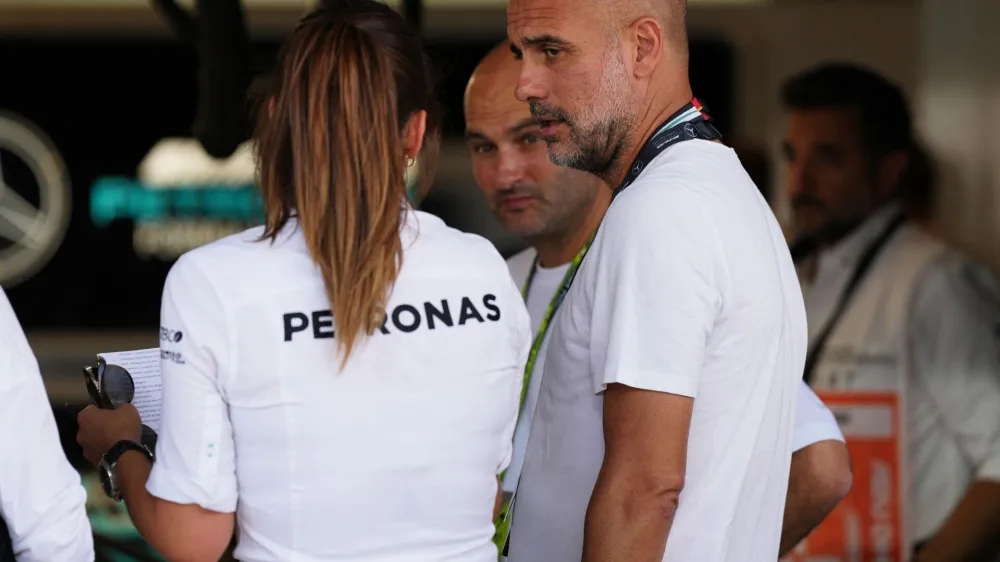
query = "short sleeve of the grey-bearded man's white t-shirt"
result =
(585, 185, 726, 398)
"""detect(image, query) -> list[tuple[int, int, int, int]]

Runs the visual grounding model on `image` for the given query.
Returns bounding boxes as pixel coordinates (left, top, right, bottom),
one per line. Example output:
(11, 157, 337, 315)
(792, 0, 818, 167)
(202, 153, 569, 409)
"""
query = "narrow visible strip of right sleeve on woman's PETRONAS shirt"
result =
(497, 272, 532, 474)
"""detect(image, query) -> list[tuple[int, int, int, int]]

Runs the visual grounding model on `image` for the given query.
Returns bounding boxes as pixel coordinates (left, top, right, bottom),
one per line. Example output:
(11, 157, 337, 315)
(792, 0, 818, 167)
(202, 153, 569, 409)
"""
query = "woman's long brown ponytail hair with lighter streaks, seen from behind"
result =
(255, 0, 440, 365)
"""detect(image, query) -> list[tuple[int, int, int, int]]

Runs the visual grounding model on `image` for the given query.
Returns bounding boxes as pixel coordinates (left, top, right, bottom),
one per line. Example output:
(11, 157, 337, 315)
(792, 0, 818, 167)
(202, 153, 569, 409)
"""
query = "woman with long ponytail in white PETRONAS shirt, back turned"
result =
(73, 0, 530, 562)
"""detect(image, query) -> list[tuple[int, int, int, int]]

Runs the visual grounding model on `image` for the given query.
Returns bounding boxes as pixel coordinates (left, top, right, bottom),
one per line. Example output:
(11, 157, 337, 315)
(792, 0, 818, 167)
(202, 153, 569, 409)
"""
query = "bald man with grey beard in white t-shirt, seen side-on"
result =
(507, 0, 806, 562)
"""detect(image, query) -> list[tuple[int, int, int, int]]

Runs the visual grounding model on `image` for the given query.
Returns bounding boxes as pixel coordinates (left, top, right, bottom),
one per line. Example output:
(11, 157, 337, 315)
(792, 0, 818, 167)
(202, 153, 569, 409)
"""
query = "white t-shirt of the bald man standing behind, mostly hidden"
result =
(503, 248, 844, 492)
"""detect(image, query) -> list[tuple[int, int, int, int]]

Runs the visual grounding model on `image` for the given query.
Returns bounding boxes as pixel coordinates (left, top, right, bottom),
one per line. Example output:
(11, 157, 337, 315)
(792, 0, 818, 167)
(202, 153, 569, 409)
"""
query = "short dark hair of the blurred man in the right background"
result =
(782, 62, 913, 163)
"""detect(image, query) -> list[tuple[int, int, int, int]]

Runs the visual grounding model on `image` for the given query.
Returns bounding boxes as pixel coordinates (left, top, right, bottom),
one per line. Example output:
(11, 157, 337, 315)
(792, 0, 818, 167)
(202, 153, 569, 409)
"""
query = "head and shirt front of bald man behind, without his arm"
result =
(465, 42, 611, 493)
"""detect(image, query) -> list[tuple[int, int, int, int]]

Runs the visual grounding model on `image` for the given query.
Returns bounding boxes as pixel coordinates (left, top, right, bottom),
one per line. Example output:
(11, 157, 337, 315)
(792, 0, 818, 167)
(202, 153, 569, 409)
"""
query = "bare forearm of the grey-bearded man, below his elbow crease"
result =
(583, 471, 680, 562)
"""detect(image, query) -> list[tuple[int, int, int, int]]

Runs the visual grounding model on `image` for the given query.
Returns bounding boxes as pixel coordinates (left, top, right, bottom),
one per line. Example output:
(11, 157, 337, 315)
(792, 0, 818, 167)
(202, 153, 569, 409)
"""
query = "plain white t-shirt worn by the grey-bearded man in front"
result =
(509, 141, 806, 562)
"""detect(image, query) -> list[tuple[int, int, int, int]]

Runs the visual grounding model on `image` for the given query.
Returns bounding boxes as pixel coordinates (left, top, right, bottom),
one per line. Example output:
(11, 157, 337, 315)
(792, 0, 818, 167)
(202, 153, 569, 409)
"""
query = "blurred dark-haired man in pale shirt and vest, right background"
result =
(783, 60, 1000, 562)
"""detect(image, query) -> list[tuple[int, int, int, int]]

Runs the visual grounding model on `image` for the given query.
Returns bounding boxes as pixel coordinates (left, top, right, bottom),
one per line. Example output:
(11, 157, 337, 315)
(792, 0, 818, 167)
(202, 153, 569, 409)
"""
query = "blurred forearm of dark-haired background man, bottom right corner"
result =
(916, 480, 1000, 562)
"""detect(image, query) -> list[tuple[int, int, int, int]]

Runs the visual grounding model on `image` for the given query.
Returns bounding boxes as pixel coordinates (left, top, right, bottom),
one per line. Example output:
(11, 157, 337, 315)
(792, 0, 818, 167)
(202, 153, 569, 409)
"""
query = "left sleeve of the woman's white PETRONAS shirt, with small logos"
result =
(146, 256, 236, 513)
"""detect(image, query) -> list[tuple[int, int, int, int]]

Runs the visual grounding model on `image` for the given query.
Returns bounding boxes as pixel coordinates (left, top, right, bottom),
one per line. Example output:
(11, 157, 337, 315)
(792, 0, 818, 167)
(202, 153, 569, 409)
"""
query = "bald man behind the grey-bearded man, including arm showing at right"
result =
(465, 42, 851, 552)
